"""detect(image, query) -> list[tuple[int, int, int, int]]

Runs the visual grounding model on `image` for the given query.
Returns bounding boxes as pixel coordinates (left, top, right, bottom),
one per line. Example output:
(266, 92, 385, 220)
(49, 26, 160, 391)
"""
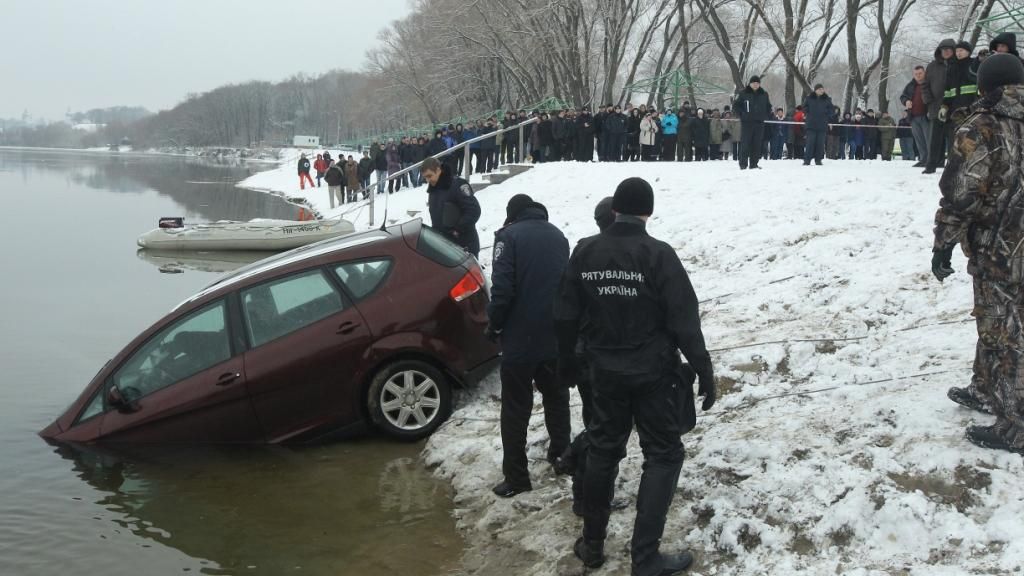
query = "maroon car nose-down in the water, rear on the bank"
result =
(40, 220, 498, 443)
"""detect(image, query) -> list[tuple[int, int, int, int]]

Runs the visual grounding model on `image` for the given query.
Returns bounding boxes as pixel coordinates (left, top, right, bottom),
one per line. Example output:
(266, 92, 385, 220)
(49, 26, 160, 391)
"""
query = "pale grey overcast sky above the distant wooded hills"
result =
(0, 0, 410, 120)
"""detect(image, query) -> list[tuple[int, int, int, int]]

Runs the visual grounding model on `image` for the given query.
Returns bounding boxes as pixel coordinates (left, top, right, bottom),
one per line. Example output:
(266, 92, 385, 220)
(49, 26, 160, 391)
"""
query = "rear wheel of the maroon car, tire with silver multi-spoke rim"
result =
(367, 360, 452, 441)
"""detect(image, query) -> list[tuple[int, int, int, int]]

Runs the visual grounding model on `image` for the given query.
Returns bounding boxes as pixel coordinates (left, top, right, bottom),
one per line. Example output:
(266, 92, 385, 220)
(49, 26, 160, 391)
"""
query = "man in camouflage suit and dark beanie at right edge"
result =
(932, 54, 1024, 454)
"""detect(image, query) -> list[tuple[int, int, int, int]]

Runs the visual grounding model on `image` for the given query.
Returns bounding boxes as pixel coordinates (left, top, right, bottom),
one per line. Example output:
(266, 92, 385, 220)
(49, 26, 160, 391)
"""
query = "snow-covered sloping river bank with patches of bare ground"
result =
(237, 156, 1024, 576)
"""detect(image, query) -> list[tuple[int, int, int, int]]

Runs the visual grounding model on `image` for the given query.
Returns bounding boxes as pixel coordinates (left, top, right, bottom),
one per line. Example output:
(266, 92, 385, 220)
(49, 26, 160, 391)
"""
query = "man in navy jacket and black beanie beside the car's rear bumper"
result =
(486, 194, 571, 498)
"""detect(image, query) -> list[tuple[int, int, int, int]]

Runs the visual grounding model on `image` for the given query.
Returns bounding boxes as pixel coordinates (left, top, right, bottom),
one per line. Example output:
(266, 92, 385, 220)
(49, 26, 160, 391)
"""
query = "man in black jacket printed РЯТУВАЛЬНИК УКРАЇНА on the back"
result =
(555, 178, 715, 576)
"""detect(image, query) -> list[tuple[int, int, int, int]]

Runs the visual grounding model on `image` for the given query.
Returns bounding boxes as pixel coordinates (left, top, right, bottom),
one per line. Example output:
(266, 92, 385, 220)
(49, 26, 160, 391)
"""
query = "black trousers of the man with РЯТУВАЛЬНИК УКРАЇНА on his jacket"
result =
(583, 369, 684, 576)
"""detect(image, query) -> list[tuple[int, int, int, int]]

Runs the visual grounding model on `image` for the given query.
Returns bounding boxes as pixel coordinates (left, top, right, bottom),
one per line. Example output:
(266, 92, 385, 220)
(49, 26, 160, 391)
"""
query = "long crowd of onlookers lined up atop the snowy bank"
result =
(299, 33, 1017, 200)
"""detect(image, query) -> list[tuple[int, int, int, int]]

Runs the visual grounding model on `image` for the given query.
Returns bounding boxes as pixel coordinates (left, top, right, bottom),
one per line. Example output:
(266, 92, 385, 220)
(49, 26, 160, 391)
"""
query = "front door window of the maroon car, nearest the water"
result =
(112, 300, 231, 399)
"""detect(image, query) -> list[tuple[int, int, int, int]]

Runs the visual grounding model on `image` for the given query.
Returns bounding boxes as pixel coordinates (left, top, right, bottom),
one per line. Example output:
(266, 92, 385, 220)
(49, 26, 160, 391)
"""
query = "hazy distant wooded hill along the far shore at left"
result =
(0, 71, 422, 148)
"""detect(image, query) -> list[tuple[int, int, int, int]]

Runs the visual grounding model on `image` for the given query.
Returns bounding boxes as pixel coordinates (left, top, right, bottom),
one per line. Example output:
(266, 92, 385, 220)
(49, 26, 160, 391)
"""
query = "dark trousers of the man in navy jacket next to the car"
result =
(501, 360, 571, 488)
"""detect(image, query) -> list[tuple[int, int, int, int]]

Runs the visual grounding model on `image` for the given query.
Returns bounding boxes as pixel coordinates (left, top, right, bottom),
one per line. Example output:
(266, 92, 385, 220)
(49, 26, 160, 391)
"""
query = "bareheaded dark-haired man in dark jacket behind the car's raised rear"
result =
(422, 158, 480, 256)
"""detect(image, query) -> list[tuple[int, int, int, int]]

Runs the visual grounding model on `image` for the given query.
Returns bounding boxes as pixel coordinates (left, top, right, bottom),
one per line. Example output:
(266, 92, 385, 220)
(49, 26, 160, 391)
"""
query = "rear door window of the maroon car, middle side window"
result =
(242, 270, 345, 346)
